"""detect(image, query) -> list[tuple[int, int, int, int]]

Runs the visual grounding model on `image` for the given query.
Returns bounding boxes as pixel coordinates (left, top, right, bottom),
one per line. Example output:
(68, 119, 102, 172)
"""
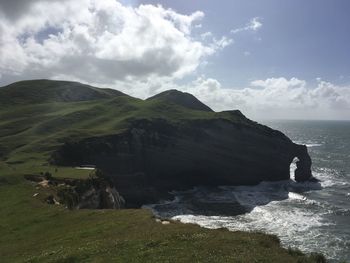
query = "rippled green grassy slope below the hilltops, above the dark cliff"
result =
(0, 92, 246, 167)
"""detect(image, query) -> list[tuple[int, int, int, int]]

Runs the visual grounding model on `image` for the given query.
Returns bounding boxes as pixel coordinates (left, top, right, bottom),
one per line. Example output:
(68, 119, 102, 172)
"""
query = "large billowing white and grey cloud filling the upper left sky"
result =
(0, 0, 232, 84)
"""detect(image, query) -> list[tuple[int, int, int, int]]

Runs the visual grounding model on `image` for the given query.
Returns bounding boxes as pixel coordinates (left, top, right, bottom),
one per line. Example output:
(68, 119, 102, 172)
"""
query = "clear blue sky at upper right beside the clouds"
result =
(138, 0, 350, 86)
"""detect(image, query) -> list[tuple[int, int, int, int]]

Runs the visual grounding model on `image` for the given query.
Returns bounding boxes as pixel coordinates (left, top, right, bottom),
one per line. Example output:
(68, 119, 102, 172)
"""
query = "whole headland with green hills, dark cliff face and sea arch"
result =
(0, 80, 312, 207)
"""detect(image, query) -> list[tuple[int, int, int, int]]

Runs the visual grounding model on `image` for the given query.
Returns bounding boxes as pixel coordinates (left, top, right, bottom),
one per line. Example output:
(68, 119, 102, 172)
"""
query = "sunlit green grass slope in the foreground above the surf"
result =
(0, 164, 326, 262)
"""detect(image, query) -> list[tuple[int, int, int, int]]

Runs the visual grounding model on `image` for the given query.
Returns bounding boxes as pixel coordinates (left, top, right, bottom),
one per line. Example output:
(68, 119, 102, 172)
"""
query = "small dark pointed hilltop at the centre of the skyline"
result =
(147, 89, 213, 112)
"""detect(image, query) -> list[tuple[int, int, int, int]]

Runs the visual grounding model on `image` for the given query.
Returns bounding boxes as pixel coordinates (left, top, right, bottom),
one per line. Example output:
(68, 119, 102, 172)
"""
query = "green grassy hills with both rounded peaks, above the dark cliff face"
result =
(0, 80, 251, 167)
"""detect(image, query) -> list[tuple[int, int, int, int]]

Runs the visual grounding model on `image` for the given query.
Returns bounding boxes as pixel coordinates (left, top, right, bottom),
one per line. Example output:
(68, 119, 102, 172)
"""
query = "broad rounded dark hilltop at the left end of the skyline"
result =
(0, 79, 127, 105)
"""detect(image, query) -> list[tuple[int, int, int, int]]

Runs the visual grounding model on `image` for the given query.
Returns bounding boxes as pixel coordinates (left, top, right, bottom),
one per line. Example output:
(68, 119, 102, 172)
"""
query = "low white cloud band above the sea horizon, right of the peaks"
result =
(148, 76, 350, 119)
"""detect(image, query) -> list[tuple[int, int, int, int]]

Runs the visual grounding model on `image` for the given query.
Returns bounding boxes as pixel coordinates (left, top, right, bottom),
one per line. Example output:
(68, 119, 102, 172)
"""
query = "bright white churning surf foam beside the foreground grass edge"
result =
(172, 193, 333, 257)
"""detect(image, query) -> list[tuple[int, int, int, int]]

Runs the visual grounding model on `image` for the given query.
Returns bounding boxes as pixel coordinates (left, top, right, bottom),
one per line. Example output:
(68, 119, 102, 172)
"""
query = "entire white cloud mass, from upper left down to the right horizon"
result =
(0, 0, 350, 119)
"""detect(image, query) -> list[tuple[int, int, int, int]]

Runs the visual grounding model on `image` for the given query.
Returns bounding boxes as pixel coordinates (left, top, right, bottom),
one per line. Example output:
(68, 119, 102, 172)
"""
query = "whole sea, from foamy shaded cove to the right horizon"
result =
(148, 121, 350, 262)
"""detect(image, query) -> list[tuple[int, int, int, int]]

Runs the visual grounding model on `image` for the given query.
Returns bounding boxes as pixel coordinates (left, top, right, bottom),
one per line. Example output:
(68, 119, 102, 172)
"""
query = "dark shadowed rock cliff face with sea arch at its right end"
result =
(53, 119, 312, 206)
